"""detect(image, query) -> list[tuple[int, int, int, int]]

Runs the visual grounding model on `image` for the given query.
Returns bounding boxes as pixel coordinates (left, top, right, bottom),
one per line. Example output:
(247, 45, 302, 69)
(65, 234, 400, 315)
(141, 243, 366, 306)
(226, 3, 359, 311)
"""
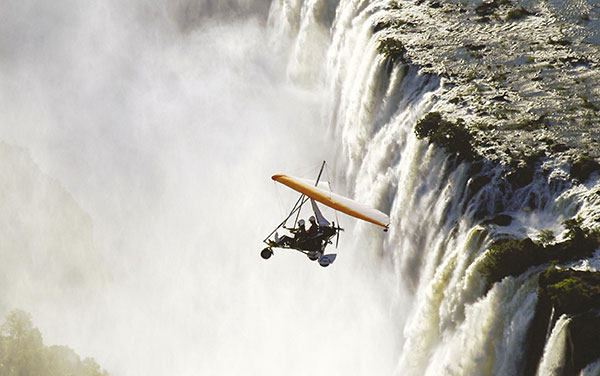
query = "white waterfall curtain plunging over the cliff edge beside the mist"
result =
(274, 0, 600, 375)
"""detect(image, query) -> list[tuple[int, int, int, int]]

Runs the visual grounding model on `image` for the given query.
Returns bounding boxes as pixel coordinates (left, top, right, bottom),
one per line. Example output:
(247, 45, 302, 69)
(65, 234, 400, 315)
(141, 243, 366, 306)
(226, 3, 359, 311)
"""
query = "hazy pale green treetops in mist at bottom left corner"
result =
(0, 310, 107, 376)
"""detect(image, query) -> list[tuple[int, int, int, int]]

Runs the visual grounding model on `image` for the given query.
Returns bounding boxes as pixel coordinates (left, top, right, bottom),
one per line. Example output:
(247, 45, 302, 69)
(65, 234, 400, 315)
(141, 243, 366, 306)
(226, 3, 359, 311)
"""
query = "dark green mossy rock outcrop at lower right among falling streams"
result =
(480, 218, 600, 375)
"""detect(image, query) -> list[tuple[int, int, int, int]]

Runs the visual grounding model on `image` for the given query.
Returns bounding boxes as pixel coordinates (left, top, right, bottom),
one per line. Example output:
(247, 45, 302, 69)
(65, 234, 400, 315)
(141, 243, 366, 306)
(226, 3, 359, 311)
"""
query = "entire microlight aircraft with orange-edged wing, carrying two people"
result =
(260, 162, 390, 267)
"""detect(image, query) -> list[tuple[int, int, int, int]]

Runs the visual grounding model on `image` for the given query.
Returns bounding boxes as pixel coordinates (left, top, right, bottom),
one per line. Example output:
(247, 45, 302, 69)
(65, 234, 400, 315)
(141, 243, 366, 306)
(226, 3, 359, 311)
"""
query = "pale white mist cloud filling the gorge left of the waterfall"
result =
(0, 0, 400, 375)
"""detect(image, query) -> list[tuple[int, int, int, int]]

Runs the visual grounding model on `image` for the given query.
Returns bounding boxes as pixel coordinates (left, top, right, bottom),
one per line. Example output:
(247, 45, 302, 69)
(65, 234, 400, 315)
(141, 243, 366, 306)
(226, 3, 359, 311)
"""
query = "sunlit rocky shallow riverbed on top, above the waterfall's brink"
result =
(373, 0, 600, 163)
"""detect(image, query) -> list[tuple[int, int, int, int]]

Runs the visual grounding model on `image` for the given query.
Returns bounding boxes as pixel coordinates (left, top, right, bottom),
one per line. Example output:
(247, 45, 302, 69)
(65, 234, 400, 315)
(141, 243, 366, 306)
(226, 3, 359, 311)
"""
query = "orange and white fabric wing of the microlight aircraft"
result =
(271, 174, 390, 228)
